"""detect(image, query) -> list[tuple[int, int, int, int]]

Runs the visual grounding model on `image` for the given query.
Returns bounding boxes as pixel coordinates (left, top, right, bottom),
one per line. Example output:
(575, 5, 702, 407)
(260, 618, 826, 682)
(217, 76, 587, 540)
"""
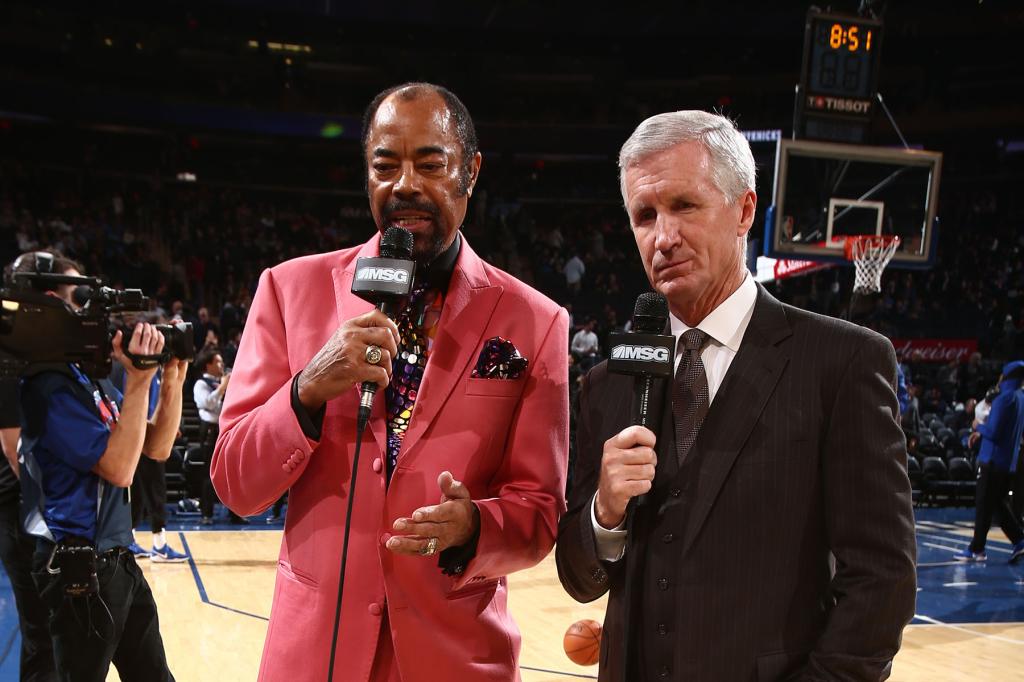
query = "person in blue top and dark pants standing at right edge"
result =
(955, 360, 1024, 563)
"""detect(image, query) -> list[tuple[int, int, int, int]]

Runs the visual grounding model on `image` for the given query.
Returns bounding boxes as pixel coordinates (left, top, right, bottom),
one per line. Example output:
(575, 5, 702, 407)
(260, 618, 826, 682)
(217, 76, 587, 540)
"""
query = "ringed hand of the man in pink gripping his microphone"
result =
(299, 310, 398, 412)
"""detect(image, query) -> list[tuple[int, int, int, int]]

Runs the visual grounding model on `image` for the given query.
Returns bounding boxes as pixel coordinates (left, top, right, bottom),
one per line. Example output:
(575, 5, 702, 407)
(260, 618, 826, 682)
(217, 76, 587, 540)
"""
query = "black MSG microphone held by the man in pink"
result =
(352, 226, 416, 433)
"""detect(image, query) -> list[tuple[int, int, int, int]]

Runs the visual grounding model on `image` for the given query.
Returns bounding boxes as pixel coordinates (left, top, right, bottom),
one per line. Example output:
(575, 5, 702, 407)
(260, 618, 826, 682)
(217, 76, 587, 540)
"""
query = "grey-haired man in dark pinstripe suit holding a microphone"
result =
(556, 112, 915, 682)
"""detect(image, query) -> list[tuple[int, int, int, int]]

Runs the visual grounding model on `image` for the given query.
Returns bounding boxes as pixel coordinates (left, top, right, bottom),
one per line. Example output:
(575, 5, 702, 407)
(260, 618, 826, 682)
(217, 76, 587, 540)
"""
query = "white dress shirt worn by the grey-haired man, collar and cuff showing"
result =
(590, 272, 758, 561)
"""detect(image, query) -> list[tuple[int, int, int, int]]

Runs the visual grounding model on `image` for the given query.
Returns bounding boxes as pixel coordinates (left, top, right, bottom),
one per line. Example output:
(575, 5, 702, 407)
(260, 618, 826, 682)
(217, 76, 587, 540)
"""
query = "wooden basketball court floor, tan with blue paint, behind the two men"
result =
(75, 510, 1024, 682)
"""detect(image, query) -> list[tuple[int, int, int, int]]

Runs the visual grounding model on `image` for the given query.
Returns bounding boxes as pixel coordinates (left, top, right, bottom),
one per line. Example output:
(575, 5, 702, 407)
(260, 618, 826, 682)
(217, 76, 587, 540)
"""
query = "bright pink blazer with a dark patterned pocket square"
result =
(211, 236, 568, 682)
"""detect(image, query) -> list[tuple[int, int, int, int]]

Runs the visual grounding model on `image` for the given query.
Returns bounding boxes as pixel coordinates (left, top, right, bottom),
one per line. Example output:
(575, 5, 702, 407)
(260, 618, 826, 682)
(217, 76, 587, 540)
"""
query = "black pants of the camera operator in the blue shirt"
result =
(33, 540, 174, 682)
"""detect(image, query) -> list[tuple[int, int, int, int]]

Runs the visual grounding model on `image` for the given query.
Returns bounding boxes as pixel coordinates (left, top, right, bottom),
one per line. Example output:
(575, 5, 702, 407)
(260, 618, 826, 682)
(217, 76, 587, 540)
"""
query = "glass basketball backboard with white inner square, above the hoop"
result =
(765, 139, 942, 268)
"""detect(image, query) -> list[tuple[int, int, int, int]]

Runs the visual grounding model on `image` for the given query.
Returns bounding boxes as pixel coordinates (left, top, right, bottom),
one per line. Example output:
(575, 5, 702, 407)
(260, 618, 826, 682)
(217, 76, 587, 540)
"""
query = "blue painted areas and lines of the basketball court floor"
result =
(0, 508, 1024, 682)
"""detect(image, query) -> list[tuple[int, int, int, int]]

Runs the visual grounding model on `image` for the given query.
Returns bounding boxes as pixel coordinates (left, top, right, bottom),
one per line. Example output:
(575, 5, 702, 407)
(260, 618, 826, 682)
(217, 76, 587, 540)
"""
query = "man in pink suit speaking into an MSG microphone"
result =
(212, 83, 568, 682)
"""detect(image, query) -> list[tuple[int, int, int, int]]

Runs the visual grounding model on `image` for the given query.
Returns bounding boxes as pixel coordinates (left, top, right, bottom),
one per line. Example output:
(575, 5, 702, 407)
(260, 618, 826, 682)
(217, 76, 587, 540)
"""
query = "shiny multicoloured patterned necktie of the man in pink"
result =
(385, 289, 444, 482)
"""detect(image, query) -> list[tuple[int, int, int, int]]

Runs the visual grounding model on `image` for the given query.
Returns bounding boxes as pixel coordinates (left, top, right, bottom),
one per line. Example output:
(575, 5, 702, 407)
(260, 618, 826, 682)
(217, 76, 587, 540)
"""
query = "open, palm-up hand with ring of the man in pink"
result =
(387, 471, 480, 555)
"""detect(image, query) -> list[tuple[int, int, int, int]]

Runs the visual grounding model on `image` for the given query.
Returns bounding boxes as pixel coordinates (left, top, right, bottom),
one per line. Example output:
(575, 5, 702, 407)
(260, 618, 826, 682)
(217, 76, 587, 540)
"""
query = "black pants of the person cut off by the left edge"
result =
(0, 496, 57, 682)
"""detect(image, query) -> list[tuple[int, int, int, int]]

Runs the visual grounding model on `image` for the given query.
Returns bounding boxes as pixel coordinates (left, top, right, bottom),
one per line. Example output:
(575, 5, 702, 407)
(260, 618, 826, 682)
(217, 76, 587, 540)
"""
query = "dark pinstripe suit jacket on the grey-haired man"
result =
(556, 287, 915, 682)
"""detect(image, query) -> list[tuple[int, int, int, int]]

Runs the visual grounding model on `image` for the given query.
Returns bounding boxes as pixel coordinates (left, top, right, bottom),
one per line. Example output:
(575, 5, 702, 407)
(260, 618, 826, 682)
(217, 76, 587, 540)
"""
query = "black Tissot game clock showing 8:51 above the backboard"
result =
(801, 10, 882, 120)
